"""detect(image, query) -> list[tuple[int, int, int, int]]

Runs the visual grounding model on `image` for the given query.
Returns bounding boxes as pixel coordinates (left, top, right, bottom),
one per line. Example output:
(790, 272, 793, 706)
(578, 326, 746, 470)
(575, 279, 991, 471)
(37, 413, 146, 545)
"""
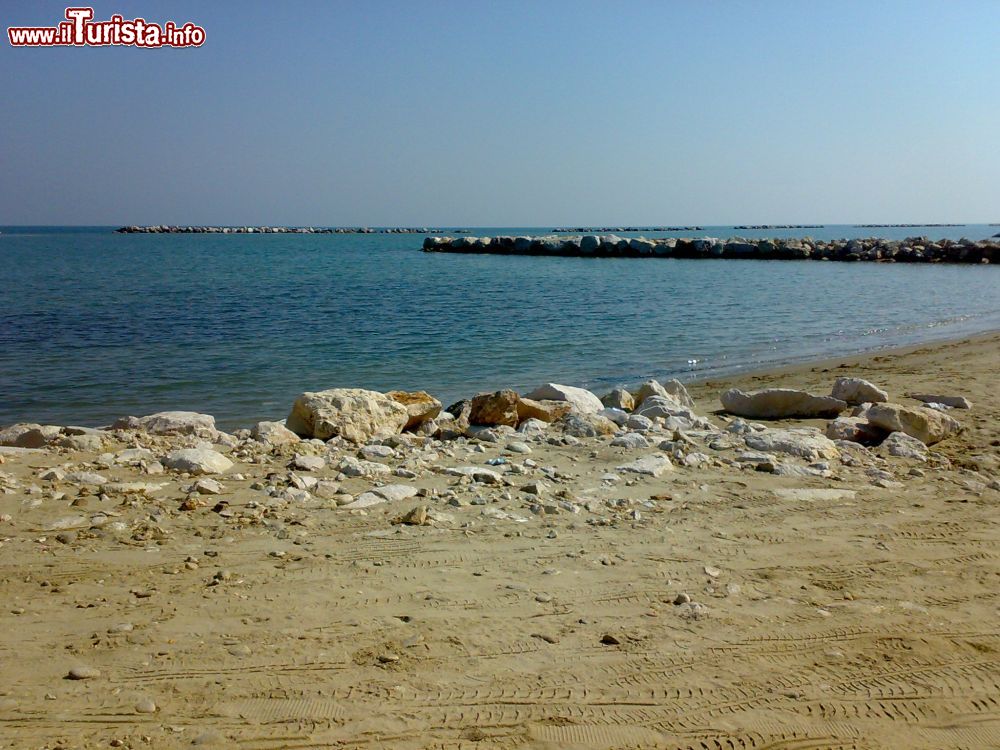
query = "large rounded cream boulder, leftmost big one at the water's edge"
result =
(285, 388, 410, 443)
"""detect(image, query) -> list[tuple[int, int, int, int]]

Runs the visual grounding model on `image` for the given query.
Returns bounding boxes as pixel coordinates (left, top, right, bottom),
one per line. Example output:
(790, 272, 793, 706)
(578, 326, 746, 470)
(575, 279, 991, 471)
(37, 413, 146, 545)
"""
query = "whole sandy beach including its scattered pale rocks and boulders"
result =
(0, 334, 1000, 750)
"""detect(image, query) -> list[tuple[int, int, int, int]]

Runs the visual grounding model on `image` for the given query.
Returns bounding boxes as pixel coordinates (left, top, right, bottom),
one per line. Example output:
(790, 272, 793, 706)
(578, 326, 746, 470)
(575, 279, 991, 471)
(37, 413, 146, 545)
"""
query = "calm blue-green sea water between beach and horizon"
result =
(0, 225, 1000, 428)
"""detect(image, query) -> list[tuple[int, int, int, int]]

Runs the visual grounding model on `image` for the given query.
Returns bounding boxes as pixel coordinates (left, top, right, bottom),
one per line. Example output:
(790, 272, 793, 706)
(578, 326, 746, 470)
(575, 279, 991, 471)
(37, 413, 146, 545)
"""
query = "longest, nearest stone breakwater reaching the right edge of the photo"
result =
(423, 235, 1000, 264)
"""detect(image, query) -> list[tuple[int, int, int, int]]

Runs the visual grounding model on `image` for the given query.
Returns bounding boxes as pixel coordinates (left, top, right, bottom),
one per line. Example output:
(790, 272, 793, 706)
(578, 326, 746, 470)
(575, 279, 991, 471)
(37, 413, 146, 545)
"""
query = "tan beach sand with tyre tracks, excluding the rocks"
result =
(0, 334, 1000, 750)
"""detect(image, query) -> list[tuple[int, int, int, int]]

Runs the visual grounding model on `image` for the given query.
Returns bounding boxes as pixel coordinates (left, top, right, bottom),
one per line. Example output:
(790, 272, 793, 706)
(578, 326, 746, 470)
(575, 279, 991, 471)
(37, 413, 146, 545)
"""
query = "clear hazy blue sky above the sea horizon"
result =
(0, 0, 1000, 227)
